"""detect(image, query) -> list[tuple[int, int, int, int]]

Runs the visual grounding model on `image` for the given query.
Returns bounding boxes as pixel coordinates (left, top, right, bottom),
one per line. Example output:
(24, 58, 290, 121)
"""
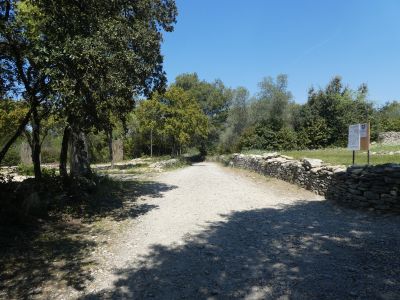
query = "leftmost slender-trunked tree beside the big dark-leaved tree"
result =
(0, 0, 50, 180)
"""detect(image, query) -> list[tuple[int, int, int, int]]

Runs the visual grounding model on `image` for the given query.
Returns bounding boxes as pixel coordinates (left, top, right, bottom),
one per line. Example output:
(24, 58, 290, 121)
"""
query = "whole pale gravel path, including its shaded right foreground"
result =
(83, 163, 400, 299)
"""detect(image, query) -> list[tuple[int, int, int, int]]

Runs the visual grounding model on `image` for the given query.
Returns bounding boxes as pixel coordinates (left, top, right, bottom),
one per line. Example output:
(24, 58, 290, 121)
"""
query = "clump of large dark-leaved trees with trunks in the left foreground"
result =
(0, 0, 177, 177)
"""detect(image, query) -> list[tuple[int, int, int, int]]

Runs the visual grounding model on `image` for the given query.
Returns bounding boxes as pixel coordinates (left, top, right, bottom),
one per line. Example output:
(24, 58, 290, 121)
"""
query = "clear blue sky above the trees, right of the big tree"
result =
(163, 0, 400, 104)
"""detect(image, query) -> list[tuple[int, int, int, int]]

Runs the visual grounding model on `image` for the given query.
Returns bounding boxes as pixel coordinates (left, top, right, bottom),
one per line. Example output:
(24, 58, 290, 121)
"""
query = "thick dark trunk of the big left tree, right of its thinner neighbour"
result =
(71, 128, 92, 177)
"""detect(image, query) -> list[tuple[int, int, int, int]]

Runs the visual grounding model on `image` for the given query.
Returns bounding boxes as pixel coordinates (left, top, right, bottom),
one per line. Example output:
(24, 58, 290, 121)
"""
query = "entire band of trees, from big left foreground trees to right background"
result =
(0, 0, 400, 195)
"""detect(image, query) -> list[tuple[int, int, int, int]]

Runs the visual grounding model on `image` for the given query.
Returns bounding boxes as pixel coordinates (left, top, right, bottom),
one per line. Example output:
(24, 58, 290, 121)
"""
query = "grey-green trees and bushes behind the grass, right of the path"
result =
(220, 75, 382, 152)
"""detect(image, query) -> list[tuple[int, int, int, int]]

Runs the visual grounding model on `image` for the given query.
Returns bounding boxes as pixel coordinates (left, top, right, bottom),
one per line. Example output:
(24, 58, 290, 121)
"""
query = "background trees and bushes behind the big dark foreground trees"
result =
(0, 73, 400, 169)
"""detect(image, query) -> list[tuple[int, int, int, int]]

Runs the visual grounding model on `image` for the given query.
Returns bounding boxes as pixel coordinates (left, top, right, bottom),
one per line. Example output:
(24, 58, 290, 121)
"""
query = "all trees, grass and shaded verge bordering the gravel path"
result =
(0, 0, 400, 298)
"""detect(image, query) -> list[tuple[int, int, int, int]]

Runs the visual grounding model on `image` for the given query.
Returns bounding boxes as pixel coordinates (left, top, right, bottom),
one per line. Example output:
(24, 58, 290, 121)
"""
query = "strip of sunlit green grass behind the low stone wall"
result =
(244, 144, 400, 165)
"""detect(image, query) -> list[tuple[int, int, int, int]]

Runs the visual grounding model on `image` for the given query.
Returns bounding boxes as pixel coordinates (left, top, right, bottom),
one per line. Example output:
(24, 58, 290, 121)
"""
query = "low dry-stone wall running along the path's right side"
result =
(218, 153, 400, 212)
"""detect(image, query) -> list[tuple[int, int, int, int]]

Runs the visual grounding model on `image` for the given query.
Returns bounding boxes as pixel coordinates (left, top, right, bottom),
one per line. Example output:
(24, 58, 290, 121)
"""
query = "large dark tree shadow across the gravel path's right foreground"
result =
(84, 201, 400, 299)
